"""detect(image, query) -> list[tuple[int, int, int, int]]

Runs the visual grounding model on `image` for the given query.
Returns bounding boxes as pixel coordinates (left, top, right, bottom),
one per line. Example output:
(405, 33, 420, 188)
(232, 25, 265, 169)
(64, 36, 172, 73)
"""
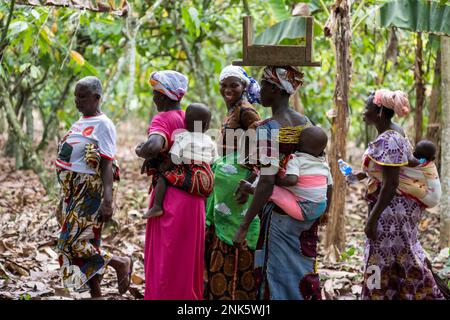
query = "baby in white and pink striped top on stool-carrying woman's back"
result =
(241, 126, 333, 221)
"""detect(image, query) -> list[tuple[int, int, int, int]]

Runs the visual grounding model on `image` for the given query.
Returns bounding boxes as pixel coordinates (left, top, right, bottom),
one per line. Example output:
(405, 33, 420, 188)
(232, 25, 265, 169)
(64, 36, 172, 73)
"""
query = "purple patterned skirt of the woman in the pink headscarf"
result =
(362, 195, 444, 300)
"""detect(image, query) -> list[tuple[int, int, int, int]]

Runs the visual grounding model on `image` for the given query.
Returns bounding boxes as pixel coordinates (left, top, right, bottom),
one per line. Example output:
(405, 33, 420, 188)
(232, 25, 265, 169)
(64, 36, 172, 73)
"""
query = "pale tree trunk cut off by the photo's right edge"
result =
(439, 36, 450, 248)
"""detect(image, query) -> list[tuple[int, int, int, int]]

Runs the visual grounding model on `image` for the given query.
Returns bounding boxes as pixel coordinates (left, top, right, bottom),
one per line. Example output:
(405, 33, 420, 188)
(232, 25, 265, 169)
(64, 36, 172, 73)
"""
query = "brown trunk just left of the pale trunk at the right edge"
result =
(427, 50, 441, 172)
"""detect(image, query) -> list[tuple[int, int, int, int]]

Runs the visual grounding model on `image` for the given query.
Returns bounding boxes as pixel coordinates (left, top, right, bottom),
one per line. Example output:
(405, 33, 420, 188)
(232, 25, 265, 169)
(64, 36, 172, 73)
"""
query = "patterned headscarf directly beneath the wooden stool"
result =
(262, 66, 303, 94)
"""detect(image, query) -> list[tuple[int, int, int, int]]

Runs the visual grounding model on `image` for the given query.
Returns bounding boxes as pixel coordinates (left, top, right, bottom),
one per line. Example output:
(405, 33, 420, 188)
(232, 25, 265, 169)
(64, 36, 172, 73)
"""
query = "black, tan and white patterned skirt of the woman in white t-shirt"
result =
(56, 169, 111, 289)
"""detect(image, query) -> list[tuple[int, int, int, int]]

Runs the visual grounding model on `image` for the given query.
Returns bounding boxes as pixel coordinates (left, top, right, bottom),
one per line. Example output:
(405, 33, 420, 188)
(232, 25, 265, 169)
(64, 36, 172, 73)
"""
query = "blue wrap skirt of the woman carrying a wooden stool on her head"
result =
(255, 202, 321, 300)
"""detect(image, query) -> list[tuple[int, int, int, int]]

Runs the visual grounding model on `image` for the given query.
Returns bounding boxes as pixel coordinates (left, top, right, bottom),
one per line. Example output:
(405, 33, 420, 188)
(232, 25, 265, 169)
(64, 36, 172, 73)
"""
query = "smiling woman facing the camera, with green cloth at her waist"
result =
(204, 66, 260, 300)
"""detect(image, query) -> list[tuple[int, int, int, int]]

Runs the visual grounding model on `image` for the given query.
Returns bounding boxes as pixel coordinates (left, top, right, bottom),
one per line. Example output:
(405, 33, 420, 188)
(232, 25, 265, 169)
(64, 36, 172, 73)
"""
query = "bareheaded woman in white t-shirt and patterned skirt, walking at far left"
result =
(55, 77, 133, 297)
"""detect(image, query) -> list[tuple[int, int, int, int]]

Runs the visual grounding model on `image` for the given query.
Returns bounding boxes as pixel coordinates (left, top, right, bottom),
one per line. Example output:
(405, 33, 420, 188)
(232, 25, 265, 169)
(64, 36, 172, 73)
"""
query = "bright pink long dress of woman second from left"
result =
(144, 110, 205, 300)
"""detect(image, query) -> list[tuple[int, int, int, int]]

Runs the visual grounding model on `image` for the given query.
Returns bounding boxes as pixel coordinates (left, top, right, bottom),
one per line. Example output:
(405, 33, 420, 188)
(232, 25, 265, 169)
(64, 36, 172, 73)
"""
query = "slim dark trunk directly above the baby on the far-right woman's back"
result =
(414, 32, 425, 143)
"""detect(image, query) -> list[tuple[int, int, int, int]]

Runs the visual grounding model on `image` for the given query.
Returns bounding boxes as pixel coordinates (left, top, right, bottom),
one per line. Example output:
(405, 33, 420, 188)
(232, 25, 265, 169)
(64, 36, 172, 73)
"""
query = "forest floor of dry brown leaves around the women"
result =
(0, 121, 448, 300)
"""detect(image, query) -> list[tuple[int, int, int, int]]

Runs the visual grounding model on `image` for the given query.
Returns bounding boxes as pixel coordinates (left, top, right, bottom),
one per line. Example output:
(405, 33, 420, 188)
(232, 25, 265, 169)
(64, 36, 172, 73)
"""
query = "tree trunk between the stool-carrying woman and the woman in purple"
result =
(325, 0, 352, 258)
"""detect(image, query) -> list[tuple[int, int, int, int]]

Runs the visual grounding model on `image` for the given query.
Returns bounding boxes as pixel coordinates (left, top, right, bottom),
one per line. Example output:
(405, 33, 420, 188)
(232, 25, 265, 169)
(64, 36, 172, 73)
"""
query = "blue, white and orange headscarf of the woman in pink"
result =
(148, 70, 188, 101)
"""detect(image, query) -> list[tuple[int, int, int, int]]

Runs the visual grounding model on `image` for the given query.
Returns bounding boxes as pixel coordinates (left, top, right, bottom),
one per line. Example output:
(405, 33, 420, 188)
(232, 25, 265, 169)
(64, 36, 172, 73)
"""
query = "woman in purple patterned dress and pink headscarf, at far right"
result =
(362, 90, 443, 300)
